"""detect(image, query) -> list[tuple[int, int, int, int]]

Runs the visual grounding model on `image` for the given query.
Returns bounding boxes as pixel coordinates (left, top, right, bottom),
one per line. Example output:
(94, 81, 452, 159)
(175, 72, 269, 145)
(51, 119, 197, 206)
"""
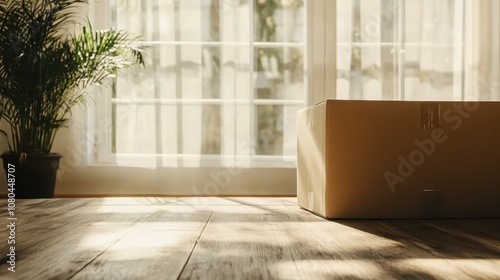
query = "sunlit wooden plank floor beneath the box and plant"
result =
(0, 198, 500, 279)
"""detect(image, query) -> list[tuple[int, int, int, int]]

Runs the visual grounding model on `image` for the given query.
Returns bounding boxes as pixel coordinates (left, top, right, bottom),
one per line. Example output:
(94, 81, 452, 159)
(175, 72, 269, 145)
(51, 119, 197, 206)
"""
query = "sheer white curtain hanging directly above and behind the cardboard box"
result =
(337, 0, 500, 100)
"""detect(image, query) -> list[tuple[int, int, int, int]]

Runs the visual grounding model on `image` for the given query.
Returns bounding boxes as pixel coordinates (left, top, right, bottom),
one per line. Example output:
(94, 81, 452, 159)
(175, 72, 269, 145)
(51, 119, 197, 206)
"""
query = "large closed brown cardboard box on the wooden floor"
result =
(297, 100, 500, 218)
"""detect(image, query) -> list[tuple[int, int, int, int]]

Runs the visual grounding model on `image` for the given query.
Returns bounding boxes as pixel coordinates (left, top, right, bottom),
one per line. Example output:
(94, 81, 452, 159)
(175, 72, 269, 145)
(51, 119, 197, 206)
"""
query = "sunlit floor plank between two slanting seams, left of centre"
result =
(73, 209, 211, 279)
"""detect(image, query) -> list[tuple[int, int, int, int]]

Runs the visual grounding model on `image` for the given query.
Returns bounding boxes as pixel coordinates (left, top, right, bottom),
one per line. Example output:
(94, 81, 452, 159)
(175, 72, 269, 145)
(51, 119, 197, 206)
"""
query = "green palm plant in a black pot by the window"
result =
(0, 0, 144, 198)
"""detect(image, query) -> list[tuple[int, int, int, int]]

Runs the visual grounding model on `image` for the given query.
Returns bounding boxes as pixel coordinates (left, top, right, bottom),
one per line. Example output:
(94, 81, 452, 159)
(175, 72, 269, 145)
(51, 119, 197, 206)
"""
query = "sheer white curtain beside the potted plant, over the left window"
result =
(112, 0, 251, 166)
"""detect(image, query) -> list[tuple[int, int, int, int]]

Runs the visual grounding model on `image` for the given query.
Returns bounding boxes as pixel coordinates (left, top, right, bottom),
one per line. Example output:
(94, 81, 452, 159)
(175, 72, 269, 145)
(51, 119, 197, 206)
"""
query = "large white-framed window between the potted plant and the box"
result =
(93, 0, 306, 167)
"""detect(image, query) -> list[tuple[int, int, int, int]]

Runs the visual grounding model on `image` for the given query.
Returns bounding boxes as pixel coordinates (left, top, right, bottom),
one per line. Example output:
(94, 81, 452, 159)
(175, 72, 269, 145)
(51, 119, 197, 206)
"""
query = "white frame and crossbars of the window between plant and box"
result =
(87, 0, 310, 168)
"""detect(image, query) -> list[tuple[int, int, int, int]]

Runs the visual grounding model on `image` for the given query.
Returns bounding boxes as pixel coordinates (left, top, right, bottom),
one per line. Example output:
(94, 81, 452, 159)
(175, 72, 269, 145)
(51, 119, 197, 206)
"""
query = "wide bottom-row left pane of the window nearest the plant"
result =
(113, 104, 222, 155)
